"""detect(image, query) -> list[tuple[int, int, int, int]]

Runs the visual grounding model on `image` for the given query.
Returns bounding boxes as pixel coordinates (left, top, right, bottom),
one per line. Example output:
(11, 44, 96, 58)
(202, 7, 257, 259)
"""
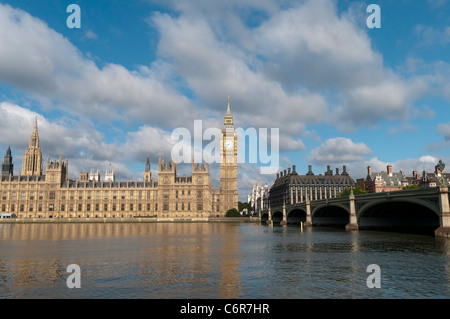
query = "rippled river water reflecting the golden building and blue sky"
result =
(0, 223, 450, 299)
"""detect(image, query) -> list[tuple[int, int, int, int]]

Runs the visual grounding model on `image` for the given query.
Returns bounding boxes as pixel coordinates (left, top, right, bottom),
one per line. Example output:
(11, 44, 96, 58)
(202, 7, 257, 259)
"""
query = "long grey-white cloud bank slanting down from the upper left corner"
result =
(0, 4, 199, 127)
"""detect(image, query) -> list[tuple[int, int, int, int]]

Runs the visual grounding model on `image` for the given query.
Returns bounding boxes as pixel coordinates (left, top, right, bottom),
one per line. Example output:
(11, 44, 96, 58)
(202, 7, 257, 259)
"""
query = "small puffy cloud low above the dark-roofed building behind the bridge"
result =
(307, 137, 372, 165)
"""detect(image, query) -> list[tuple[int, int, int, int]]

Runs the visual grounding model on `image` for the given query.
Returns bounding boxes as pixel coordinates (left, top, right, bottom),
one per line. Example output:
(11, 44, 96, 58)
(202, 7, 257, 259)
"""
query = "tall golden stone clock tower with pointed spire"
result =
(220, 97, 238, 214)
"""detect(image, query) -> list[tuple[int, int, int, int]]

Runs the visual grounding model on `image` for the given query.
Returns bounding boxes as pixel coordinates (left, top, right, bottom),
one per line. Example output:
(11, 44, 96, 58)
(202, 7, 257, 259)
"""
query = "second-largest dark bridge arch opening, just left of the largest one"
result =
(311, 203, 350, 227)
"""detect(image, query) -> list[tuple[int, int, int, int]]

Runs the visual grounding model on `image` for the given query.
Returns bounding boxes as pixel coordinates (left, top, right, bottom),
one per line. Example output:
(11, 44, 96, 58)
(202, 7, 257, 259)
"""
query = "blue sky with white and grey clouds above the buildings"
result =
(0, 0, 450, 201)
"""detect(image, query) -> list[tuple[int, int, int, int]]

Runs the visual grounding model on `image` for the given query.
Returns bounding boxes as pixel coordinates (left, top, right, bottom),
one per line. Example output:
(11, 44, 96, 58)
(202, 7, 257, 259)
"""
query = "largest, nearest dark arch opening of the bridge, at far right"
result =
(356, 198, 440, 233)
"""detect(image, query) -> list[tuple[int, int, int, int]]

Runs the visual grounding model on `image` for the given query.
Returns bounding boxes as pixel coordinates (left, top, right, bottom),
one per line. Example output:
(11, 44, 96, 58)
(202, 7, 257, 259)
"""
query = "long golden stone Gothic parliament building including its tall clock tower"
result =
(0, 100, 238, 221)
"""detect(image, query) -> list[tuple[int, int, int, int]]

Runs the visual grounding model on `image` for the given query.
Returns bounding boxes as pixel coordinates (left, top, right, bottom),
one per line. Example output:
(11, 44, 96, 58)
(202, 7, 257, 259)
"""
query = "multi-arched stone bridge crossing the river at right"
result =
(261, 186, 450, 237)
